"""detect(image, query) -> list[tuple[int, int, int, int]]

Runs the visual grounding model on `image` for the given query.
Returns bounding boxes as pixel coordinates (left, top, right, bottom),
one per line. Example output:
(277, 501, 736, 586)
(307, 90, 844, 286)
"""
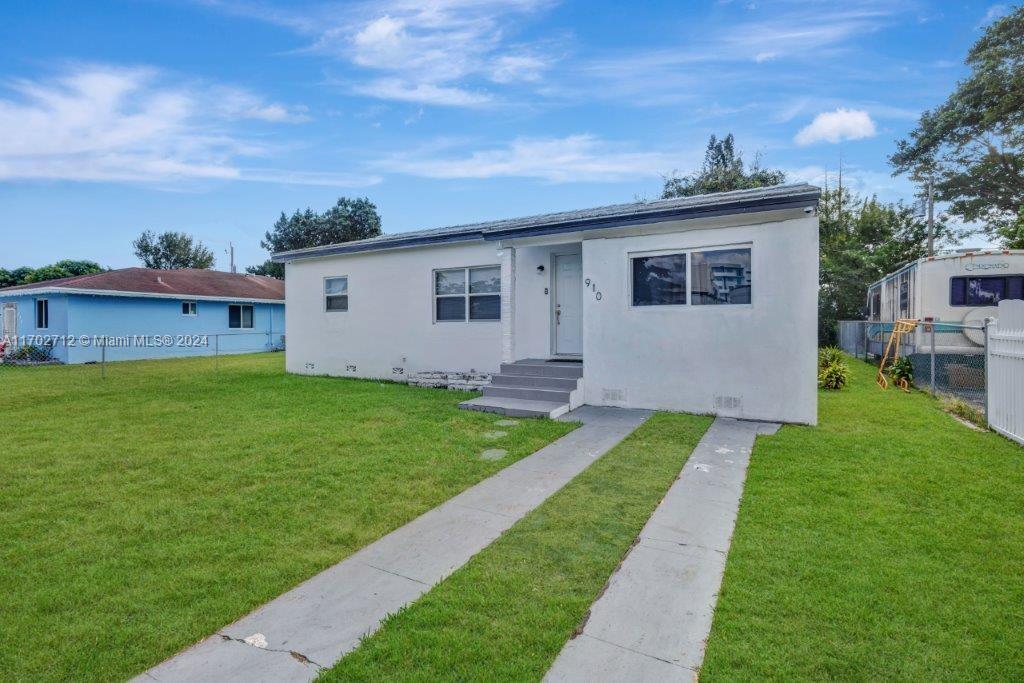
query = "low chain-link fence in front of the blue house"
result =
(0, 332, 285, 376)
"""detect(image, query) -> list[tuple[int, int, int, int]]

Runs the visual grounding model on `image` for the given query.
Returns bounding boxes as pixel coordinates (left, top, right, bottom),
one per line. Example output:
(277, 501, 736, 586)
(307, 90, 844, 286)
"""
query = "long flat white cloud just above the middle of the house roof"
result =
(379, 134, 680, 182)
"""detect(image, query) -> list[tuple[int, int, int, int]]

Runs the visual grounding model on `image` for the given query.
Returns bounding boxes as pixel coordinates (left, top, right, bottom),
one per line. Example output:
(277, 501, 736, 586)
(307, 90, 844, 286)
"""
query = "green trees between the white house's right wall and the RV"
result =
(818, 188, 963, 344)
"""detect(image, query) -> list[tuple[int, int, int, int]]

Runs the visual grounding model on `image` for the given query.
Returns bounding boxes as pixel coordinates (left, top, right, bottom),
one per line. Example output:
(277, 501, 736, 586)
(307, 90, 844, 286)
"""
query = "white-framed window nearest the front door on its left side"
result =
(434, 265, 502, 323)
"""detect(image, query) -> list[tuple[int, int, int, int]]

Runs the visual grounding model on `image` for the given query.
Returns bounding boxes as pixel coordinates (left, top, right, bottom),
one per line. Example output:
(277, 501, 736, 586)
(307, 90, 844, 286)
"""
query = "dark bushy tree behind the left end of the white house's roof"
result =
(246, 197, 381, 278)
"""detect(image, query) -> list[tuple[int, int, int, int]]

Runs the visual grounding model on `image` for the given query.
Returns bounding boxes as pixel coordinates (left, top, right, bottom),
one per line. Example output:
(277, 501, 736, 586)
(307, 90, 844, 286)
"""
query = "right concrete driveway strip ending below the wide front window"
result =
(545, 418, 778, 681)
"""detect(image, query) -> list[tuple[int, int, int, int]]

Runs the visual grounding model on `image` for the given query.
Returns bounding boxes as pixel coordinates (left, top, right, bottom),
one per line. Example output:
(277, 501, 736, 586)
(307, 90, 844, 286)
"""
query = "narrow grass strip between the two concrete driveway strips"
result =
(321, 414, 711, 681)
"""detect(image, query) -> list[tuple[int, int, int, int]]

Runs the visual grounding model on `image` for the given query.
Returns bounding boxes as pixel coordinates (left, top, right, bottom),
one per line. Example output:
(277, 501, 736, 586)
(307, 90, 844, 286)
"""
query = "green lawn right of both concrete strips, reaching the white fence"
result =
(701, 359, 1024, 681)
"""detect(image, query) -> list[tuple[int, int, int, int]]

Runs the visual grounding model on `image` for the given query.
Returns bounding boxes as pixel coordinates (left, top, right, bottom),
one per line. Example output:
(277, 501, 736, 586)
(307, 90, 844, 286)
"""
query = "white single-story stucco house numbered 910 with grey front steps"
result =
(273, 184, 820, 424)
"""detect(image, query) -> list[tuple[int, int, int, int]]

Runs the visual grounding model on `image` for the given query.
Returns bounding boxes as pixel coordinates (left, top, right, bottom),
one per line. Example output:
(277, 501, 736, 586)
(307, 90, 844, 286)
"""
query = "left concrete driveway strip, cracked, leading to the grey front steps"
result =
(136, 407, 649, 681)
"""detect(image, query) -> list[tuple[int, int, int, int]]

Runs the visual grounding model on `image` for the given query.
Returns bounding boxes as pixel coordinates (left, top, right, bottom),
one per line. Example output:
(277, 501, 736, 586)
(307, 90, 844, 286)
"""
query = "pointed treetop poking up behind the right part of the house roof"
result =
(662, 133, 785, 199)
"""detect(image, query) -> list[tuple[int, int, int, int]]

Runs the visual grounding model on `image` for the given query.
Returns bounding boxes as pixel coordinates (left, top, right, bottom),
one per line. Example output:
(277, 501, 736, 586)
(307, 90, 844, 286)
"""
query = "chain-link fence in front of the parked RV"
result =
(839, 321, 987, 412)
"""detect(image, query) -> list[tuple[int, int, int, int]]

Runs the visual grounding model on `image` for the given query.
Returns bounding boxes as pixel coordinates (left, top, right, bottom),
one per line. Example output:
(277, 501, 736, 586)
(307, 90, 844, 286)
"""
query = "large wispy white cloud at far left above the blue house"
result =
(0, 65, 372, 184)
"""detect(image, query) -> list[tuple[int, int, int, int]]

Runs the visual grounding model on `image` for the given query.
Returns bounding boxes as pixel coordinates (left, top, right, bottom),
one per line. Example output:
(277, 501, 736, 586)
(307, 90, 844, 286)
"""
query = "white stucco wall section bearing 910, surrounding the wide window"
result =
(583, 216, 818, 424)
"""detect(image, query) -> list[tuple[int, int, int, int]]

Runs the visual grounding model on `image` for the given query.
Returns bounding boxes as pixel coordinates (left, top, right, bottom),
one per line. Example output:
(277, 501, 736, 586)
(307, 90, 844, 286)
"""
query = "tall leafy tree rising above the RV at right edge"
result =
(889, 7, 1024, 248)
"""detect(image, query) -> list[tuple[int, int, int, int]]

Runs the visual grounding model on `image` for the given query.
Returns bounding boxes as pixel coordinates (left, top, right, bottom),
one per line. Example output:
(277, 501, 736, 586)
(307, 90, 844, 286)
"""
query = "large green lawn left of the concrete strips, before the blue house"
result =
(0, 354, 571, 681)
